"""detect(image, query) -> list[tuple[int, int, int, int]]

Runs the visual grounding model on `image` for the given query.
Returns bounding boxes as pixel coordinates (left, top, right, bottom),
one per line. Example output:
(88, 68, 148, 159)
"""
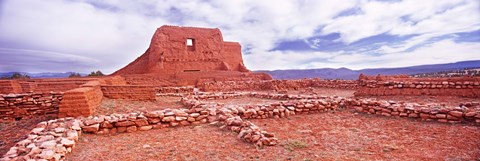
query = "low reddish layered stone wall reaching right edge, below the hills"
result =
(355, 75, 480, 98)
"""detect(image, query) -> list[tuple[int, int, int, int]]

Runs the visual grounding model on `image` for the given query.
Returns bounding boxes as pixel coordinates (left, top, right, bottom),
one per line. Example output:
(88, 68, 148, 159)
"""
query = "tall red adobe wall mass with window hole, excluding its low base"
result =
(113, 26, 248, 75)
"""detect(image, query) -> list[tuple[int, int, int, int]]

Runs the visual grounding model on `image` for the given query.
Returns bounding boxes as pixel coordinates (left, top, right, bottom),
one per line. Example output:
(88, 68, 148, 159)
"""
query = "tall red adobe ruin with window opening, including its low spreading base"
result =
(112, 26, 272, 85)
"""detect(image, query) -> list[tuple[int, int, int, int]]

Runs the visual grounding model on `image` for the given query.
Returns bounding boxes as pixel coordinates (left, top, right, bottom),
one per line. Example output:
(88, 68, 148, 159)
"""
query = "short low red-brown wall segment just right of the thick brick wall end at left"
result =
(101, 85, 155, 101)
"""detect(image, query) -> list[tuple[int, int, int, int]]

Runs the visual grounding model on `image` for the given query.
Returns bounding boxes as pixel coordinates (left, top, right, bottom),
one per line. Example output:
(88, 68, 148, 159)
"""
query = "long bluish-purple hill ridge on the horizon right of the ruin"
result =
(257, 60, 480, 80)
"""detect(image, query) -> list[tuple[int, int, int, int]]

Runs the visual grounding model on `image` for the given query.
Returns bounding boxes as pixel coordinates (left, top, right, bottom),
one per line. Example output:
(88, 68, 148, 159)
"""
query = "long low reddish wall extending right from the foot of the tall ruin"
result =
(197, 79, 357, 91)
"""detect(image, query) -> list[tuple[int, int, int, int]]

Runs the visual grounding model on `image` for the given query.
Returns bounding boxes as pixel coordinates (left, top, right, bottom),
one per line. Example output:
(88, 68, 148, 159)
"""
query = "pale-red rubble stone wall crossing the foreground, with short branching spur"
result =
(2, 93, 480, 160)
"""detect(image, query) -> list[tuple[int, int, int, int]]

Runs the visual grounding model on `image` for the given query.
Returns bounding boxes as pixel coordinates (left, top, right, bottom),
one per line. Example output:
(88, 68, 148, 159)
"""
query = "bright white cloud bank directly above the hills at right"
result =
(297, 39, 480, 69)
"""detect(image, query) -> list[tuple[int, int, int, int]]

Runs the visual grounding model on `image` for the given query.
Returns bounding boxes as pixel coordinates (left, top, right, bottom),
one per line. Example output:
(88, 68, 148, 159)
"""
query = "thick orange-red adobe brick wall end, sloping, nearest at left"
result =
(59, 85, 103, 117)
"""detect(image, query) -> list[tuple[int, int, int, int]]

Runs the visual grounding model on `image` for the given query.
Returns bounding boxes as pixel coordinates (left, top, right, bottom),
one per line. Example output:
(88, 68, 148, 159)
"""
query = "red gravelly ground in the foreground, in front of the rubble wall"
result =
(67, 110, 480, 161)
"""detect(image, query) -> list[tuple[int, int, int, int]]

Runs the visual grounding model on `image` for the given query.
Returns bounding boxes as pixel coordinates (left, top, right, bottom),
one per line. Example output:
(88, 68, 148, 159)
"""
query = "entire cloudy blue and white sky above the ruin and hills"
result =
(0, 0, 480, 73)
